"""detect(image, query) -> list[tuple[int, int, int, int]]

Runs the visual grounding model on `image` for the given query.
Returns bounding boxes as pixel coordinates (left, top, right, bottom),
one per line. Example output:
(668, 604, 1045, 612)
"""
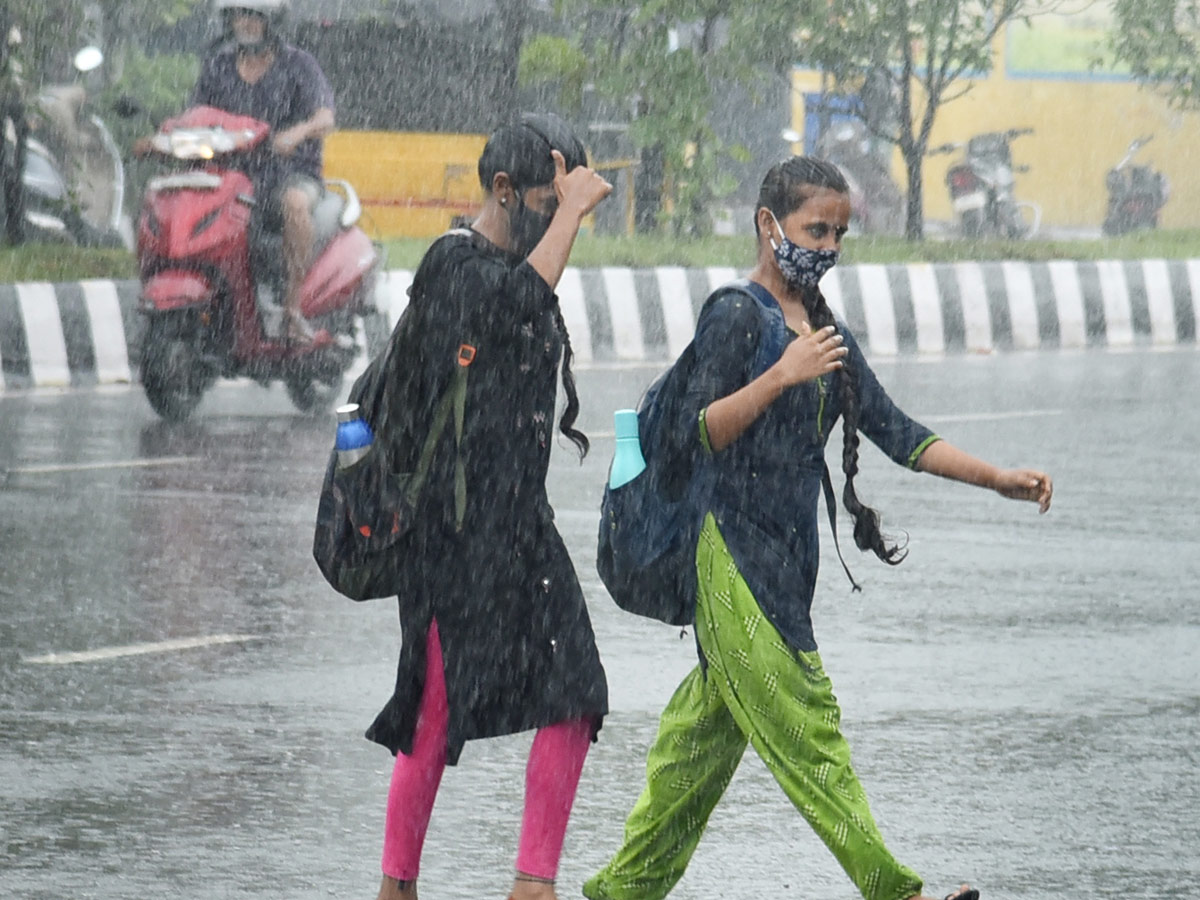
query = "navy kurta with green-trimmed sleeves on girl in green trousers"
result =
(677, 290, 937, 650)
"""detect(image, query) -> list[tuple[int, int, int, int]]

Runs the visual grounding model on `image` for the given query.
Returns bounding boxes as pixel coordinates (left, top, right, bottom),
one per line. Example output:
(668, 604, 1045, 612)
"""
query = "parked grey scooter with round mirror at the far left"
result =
(22, 47, 125, 247)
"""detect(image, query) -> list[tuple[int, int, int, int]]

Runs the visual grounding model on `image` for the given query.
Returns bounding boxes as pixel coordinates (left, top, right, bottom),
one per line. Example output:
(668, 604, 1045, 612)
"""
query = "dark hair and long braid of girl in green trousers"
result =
(755, 156, 907, 565)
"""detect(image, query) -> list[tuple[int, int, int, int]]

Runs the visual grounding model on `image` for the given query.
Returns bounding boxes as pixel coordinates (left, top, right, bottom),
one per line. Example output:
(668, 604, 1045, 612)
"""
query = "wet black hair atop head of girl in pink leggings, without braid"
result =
(479, 113, 588, 191)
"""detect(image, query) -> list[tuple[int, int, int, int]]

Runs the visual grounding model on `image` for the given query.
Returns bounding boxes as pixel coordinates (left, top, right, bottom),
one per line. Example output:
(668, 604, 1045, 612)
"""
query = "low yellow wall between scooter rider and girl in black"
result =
(325, 131, 487, 238)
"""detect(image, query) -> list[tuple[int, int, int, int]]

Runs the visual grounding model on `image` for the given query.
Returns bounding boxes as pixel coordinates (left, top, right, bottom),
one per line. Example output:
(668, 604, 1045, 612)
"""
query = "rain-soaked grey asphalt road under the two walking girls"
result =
(0, 349, 1200, 900)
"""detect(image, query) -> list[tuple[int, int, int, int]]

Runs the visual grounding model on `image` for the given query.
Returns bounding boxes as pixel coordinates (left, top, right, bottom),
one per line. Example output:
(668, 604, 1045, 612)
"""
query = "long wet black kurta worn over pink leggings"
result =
(367, 230, 608, 764)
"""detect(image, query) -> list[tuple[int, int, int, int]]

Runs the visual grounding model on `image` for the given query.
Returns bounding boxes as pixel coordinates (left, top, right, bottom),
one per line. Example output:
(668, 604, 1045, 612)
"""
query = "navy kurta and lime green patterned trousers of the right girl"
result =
(583, 282, 937, 900)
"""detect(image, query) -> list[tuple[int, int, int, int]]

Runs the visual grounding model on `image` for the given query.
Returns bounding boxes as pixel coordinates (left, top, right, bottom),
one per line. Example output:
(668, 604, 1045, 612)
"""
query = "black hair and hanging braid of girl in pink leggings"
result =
(479, 113, 592, 460)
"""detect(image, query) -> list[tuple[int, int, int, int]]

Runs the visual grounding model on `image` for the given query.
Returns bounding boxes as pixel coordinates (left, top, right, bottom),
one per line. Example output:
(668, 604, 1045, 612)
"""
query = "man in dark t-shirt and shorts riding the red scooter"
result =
(139, 0, 334, 343)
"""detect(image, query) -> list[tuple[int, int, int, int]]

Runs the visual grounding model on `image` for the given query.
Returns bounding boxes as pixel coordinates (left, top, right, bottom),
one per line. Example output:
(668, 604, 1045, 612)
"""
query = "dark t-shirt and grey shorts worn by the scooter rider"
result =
(191, 44, 334, 197)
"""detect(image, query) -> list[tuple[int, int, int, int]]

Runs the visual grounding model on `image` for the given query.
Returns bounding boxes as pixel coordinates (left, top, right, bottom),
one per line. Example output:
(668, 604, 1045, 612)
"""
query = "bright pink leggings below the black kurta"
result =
(383, 622, 592, 881)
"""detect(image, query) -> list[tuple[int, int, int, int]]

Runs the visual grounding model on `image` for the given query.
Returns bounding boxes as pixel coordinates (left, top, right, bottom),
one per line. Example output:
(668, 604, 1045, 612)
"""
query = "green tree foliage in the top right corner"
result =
(1109, 0, 1200, 108)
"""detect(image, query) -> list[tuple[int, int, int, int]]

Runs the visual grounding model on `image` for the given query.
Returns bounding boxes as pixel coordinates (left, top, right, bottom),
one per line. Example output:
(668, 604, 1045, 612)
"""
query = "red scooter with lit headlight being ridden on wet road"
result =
(138, 107, 380, 420)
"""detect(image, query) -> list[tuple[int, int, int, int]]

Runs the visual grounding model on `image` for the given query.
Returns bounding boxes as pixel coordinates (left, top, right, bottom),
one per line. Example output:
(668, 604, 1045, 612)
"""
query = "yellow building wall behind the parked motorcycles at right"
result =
(792, 28, 1200, 228)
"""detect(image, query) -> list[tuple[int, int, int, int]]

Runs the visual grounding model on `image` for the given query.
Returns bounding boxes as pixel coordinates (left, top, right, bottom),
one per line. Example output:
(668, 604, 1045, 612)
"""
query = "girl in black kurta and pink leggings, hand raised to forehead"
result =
(367, 116, 611, 900)
